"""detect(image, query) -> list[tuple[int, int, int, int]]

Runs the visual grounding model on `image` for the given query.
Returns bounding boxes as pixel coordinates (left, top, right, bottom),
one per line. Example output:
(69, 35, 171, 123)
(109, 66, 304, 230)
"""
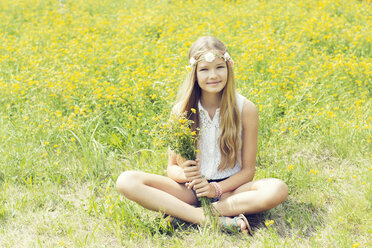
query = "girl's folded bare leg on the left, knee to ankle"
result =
(116, 171, 205, 224)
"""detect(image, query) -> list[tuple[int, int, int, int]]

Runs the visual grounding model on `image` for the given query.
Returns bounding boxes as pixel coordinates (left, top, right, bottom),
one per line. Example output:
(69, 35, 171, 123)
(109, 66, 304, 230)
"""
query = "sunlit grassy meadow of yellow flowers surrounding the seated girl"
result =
(0, 0, 372, 247)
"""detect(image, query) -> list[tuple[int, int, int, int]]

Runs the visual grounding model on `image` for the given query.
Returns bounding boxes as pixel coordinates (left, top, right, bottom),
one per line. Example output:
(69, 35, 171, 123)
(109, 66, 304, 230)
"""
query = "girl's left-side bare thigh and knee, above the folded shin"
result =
(116, 171, 196, 204)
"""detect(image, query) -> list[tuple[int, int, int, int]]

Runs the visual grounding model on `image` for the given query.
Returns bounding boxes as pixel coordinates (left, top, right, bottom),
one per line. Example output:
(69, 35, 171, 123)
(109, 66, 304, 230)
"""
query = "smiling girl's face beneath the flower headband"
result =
(196, 57, 228, 94)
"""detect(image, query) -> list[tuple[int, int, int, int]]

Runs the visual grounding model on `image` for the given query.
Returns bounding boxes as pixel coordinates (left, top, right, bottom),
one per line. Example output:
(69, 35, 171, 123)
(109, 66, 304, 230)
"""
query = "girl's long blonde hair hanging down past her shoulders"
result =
(176, 36, 242, 171)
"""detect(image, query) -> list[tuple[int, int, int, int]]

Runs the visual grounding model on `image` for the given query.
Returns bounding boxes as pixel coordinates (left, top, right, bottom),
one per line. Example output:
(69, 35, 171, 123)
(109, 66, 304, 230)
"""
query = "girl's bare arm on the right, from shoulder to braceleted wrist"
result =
(218, 99, 258, 192)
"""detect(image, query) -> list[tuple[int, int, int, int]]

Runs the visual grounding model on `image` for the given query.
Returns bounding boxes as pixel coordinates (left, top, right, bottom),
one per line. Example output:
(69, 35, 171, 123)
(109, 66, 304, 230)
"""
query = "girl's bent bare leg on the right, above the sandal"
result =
(214, 178, 288, 216)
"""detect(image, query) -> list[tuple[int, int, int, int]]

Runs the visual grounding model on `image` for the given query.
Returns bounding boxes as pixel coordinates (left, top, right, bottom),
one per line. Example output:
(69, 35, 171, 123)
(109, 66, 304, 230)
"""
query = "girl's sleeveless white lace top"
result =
(198, 94, 244, 179)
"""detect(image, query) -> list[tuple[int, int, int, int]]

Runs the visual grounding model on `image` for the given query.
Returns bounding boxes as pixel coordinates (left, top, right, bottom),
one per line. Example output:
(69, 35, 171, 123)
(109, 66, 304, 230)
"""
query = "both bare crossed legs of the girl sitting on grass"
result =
(116, 171, 288, 224)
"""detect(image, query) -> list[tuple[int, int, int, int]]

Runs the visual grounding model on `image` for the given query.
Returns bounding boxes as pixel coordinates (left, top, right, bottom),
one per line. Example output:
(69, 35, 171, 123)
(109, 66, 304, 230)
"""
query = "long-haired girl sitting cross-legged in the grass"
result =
(116, 36, 288, 233)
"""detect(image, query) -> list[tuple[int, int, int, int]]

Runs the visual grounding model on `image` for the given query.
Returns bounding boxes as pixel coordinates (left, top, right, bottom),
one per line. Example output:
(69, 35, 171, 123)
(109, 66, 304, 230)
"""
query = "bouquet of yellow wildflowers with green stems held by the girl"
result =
(165, 108, 213, 223)
